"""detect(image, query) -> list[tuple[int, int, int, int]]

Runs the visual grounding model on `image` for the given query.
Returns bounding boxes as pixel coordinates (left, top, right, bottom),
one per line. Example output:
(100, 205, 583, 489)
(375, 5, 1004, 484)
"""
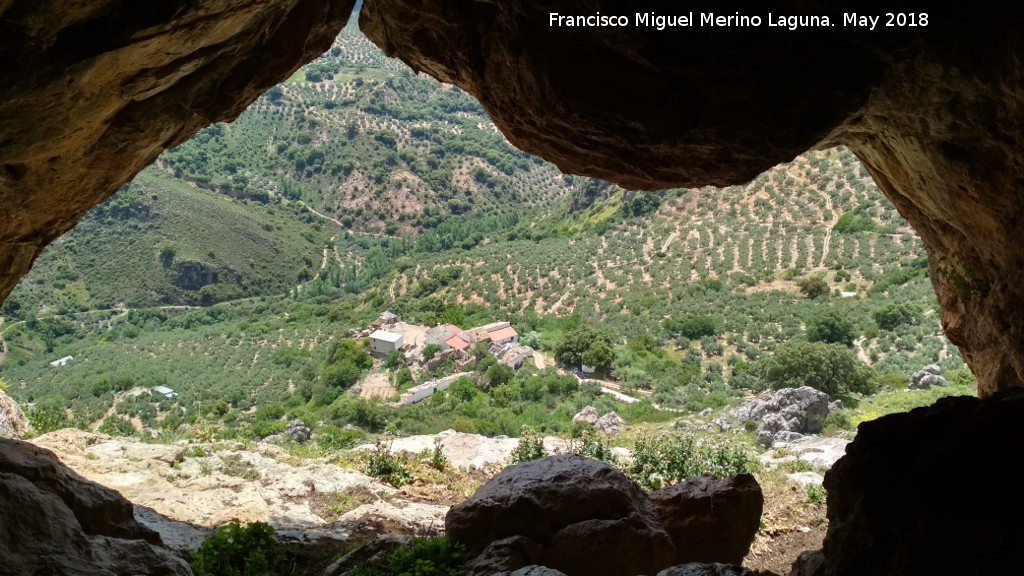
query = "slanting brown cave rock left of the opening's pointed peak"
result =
(0, 0, 354, 301)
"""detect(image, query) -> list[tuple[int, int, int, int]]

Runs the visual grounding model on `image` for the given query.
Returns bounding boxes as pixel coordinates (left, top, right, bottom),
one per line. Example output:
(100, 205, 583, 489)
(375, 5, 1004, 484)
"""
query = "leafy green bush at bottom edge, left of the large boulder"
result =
(189, 521, 294, 576)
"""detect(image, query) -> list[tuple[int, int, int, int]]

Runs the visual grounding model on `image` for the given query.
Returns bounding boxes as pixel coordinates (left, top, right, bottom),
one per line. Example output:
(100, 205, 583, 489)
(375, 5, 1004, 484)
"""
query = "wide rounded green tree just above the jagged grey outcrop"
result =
(761, 342, 873, 398)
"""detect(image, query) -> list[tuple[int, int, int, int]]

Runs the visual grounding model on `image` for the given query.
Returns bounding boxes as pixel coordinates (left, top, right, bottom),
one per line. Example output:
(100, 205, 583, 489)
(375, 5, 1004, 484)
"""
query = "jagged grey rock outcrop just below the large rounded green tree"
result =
(719, 386, 831, 448)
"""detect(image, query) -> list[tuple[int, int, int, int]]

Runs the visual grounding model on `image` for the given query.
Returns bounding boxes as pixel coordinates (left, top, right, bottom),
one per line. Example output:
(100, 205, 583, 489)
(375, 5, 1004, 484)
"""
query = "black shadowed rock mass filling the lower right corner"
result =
(824, 393, 1024, 576)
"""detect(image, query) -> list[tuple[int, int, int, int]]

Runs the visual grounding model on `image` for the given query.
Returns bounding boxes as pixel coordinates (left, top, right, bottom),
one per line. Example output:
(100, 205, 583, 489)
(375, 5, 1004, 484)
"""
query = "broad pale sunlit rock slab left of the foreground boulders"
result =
(32, 429, 447, 528)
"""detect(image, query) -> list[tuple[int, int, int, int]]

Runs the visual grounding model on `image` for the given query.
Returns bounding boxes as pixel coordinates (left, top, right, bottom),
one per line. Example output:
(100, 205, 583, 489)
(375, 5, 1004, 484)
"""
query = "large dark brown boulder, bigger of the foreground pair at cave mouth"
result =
(444, 454, 675, 576)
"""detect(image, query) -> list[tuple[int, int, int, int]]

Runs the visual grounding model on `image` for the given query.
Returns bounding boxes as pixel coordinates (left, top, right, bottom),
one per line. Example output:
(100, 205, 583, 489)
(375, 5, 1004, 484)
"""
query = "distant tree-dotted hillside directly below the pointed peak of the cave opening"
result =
(158, 23, 567, 235)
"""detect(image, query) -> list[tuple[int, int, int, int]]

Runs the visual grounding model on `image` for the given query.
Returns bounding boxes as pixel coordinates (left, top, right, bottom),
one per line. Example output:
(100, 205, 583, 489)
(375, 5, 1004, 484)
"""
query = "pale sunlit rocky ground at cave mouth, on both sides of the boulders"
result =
(19, 429, 846, 574)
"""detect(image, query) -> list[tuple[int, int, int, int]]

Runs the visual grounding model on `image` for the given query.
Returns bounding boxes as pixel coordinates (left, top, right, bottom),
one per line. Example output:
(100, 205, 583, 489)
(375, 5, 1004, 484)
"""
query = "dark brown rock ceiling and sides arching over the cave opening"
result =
(0, 0, 1024, 395)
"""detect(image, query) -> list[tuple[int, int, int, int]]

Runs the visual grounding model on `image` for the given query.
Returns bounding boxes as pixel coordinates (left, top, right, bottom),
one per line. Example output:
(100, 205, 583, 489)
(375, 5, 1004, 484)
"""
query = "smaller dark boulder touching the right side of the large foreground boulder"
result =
(650, 474, 764, 564)
